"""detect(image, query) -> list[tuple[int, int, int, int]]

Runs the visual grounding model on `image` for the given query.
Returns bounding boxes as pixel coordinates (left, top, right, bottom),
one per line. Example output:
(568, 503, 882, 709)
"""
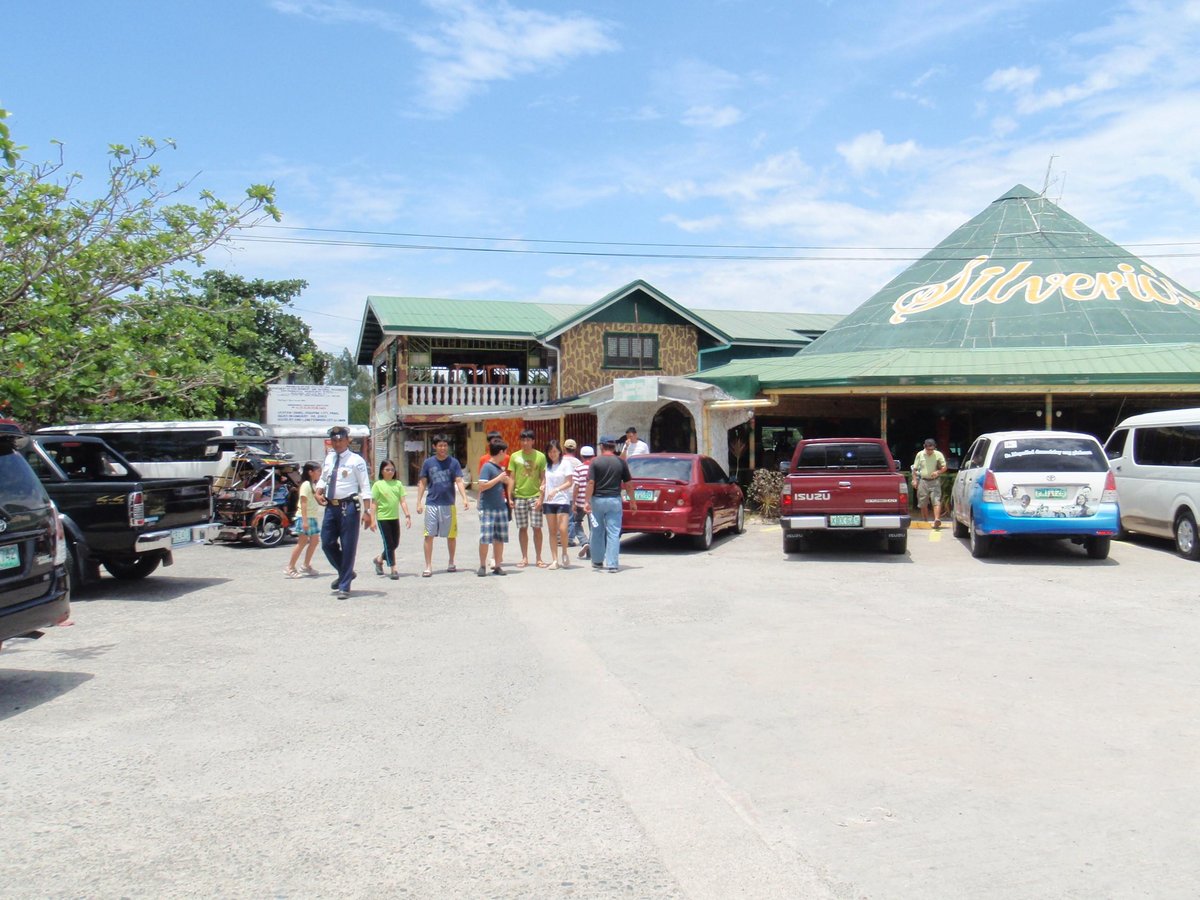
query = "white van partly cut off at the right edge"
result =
(1104, 409, 1200, 559)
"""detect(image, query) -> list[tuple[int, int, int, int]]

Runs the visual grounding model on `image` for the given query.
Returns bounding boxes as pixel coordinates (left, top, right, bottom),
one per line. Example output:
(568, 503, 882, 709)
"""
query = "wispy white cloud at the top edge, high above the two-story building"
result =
(410, 0, 618, 113)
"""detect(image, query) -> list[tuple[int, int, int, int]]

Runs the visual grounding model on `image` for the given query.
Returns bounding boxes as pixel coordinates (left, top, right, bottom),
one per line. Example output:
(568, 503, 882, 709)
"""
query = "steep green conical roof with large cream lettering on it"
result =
(802, 185, 1200, 358)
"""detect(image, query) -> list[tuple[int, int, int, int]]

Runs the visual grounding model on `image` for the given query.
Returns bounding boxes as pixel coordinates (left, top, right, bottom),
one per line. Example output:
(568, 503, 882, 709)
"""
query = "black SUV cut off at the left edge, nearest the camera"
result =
(0, 420, 71, 657)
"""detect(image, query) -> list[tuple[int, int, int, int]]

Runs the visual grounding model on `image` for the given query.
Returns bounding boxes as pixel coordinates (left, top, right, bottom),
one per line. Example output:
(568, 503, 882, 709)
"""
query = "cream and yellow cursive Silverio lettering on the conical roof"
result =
(889, 257, 1200, 325)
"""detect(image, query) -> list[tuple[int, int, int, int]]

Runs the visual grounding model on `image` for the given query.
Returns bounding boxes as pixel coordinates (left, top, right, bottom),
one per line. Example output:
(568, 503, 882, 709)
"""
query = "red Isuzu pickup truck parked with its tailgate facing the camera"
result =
(779, 438, 912, 553)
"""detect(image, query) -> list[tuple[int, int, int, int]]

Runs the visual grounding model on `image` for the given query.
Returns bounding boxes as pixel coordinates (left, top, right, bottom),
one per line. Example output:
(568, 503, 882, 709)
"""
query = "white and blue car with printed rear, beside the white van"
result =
(953, 431, 1121, 559)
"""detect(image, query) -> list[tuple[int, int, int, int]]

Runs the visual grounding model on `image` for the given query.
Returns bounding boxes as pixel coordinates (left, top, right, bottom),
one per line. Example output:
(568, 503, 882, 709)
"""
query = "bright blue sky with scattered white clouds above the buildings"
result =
(0, 0, 1200, 353)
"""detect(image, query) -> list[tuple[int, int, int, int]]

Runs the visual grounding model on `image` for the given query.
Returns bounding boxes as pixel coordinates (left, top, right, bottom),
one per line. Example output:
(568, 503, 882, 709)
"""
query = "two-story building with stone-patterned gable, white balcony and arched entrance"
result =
(358, 281, 839, 480)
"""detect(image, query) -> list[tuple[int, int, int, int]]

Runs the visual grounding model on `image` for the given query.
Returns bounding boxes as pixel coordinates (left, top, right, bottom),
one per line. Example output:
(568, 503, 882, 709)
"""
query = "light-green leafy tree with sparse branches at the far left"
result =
(0, 109, 286, 425)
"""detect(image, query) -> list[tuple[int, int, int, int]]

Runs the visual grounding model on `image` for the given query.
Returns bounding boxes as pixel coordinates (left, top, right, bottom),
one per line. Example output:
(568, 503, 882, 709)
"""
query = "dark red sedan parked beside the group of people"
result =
(620, 454, 746, 550)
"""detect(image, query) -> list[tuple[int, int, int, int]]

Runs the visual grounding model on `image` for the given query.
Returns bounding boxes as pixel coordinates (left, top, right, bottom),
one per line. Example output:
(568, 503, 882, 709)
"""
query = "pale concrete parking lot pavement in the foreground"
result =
(0, 512, 1200, 899)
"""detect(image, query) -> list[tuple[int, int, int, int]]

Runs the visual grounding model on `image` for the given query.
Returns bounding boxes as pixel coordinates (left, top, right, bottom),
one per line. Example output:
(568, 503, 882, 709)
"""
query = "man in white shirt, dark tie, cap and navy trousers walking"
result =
(314, 425, 374, 600)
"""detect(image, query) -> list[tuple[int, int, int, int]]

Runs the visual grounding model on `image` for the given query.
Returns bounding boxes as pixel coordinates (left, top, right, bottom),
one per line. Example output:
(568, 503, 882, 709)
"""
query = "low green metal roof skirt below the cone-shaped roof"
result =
(691, 343, 1200, 397)
